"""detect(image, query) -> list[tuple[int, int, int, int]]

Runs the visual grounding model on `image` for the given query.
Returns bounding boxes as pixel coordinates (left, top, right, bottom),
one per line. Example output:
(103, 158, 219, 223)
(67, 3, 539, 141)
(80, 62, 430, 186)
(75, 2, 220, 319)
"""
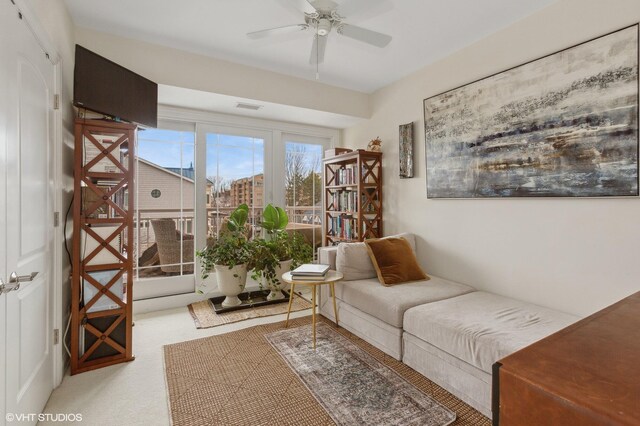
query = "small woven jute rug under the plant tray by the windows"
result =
(189, 297, 311, 328)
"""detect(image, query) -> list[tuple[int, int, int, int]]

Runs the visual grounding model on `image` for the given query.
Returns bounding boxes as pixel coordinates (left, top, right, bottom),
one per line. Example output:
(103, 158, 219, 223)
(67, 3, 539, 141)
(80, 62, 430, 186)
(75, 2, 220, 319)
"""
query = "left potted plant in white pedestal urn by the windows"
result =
(196, 204, 253, 306)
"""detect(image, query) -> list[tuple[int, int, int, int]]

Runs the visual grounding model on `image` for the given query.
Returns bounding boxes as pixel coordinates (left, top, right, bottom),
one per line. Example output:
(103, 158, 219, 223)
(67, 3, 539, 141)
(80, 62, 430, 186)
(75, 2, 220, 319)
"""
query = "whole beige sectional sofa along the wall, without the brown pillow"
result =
(319, 234, 579, 417)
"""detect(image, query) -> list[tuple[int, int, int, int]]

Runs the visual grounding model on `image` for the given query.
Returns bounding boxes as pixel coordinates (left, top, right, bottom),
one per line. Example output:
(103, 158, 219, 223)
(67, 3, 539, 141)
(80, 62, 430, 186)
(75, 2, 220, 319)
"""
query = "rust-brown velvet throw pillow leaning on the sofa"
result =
(364, 238, 429, 286)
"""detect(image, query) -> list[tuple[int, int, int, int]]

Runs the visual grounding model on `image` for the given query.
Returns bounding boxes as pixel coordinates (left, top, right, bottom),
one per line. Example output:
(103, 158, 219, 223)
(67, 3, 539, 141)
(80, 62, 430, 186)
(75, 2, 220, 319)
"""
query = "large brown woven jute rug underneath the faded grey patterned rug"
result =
(164, 317, 491, 426)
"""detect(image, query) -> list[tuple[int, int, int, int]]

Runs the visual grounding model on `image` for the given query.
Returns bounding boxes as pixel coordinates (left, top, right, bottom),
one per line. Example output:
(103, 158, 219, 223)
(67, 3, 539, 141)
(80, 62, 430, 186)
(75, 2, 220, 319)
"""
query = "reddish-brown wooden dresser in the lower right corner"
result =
(493, 292, 640, 426)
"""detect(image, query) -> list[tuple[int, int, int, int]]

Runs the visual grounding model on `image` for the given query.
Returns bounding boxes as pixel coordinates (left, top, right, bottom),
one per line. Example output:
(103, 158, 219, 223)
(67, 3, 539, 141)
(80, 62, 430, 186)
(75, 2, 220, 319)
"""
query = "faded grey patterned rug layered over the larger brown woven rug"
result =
(265, 323, 456, 426)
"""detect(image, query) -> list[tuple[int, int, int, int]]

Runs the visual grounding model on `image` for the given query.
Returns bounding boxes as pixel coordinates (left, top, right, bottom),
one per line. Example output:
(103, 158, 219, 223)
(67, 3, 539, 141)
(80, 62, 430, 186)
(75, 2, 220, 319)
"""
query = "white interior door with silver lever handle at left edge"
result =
(0, 1, 54, 424)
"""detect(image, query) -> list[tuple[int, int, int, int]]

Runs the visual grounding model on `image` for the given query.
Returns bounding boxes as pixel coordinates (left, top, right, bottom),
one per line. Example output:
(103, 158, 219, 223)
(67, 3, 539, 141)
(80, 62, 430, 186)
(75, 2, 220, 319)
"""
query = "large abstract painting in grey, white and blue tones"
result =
(424, 25, 638, 198)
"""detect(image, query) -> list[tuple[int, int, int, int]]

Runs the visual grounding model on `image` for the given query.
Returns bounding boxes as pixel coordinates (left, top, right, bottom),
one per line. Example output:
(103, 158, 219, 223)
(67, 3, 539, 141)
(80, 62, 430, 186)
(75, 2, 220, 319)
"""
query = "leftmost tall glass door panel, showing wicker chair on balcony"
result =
(134, 123, 195, 299)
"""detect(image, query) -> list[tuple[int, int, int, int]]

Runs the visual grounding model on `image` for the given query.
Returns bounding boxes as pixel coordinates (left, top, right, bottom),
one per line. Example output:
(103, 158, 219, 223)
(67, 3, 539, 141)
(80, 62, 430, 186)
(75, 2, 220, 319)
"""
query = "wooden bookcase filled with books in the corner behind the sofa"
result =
(323, 150, 382, 246)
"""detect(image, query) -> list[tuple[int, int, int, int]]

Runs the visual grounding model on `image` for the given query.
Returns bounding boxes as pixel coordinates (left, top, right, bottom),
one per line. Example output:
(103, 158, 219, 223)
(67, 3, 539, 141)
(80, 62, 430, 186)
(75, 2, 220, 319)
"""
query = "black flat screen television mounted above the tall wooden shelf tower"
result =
(73, 44, 158, 127)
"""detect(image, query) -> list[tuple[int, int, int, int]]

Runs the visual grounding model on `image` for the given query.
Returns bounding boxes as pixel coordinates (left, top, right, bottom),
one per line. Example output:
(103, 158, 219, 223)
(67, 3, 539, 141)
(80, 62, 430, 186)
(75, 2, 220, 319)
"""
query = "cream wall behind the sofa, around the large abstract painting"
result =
(343, 0, 640, 315)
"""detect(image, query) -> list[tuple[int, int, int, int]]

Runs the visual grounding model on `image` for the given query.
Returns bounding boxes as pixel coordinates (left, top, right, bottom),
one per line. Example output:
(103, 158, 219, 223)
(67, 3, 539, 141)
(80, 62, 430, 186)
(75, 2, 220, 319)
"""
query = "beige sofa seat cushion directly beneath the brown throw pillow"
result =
(335, 276, 474, 328)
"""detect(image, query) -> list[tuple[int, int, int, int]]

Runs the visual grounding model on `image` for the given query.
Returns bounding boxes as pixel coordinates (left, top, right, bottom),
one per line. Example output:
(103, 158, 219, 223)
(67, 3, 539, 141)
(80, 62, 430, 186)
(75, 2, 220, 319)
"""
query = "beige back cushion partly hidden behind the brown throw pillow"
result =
(336, 233, 416, 281)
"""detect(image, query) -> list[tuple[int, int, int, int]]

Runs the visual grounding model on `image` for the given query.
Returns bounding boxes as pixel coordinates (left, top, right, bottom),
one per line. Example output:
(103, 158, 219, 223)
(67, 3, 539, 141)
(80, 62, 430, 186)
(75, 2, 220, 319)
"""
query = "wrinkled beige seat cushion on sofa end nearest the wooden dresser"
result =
(404, 291, 579, 373)
